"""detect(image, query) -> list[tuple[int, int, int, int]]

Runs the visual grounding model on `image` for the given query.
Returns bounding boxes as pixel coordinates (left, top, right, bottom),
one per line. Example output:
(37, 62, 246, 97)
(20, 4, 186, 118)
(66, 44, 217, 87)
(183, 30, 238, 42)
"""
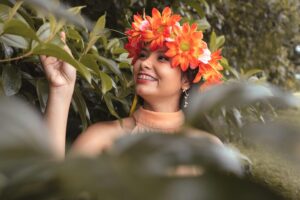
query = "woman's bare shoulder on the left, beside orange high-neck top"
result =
(71, 118, 134, 156)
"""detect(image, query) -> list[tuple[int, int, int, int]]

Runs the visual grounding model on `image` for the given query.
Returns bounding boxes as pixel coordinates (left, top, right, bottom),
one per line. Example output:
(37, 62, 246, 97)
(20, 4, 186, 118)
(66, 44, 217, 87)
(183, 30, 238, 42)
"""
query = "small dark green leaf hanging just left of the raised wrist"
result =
(36, 78, 49, 112)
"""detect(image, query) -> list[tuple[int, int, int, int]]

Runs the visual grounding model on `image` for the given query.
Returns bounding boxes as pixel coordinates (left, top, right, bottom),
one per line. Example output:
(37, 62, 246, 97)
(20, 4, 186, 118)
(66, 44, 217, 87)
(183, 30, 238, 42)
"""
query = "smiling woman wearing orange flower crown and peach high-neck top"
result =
(41, 7, 222, 158)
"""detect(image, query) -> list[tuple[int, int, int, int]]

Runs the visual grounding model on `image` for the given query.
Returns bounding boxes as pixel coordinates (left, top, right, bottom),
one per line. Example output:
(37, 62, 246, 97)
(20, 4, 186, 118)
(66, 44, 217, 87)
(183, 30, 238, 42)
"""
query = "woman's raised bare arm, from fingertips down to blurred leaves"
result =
(41, 33, 76, 159)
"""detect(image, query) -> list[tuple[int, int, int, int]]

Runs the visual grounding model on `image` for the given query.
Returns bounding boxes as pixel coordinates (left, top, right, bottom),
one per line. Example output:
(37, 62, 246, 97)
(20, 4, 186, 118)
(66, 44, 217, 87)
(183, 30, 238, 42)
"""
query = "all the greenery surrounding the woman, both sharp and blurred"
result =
(0, 0, 300, 199)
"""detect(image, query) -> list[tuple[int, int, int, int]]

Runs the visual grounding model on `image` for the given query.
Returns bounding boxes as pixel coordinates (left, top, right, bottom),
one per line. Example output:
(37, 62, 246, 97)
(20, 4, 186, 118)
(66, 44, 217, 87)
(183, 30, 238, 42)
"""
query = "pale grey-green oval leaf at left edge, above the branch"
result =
(0, 34, 29, 49)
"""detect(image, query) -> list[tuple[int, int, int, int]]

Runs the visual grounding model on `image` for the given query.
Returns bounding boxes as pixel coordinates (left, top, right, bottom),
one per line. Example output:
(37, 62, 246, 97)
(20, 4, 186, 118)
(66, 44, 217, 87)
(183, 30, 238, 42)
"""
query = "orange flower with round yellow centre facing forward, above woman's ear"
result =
(165, 23, 207, 71)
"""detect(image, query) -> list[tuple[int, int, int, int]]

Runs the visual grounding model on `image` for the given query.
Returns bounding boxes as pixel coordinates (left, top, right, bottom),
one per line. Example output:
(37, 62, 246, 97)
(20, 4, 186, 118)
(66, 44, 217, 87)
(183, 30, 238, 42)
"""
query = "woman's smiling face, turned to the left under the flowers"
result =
(133, 47, 188, 101)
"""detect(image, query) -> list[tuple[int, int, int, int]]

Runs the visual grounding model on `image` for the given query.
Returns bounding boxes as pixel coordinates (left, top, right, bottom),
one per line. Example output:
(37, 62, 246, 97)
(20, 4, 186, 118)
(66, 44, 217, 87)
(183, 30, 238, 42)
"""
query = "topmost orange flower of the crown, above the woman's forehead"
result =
(142, 7, 181, 51)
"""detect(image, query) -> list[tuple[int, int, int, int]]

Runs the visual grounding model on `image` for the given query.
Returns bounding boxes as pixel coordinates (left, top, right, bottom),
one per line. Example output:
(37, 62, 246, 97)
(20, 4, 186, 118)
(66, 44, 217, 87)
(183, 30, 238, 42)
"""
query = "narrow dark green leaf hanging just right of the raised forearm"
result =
(73, 85, 90, 130)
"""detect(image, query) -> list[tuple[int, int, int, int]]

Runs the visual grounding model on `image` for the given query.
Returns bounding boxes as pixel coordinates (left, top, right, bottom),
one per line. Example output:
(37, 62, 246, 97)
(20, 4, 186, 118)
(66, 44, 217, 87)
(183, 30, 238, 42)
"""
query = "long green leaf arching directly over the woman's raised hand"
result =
(33, 43, 91, 83)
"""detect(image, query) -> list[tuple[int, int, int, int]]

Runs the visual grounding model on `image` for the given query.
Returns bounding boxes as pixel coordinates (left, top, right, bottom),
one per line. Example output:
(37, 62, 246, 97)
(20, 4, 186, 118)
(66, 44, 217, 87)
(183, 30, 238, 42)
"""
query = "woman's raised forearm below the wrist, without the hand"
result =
(45, 87, 74, 159)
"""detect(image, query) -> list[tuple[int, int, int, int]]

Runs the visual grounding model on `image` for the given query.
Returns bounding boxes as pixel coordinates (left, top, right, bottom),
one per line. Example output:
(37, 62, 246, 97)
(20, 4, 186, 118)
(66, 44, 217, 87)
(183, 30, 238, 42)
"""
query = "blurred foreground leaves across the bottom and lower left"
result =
(0, 95, 292, 200)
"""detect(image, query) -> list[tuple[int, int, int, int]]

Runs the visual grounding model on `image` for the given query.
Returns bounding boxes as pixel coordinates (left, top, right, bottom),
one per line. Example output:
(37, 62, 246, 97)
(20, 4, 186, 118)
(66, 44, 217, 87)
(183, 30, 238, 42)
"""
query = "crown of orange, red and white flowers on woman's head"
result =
(125, 7, 223, 88)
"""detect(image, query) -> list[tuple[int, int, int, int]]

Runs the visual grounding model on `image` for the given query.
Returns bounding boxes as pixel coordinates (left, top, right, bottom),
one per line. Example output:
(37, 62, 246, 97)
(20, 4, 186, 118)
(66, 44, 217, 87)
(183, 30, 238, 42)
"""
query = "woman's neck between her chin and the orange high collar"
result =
(143, 96, 180, 113)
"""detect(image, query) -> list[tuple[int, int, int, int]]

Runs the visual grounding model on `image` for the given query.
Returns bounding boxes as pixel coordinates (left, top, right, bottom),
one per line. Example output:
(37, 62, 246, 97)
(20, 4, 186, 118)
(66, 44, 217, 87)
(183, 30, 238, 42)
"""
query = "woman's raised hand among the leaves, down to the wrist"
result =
(40, 32, 76, 89)
